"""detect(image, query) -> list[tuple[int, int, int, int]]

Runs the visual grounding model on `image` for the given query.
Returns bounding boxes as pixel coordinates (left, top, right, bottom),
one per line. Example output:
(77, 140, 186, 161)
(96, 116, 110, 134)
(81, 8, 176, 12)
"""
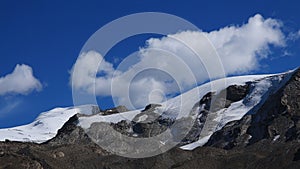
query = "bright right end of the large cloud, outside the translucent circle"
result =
(207, 15, 285, 74)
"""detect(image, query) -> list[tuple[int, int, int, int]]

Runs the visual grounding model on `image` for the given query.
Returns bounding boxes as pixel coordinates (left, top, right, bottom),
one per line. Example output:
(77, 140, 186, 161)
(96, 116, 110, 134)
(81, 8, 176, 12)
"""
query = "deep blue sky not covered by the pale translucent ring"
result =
(0, 0, 300, 128)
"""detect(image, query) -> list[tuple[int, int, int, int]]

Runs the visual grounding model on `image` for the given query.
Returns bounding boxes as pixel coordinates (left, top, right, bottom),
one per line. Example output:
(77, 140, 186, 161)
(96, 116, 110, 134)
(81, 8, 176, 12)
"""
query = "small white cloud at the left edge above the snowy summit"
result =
(0, 64, 42, 95)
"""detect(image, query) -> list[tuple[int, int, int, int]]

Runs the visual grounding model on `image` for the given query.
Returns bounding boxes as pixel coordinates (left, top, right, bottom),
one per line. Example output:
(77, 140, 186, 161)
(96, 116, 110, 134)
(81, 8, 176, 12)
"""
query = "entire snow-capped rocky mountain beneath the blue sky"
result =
(0, 69, 300, 169)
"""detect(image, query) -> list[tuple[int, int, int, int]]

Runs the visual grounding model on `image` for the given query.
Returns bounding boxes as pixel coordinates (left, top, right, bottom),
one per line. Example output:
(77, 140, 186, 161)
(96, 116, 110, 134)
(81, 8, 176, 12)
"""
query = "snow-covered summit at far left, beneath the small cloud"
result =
(0, 105, 92, 143)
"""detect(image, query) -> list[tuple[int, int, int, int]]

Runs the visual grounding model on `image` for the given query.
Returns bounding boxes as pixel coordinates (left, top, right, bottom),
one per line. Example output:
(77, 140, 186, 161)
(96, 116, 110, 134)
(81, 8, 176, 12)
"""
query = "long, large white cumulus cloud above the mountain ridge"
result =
(71, 14, 286, 108)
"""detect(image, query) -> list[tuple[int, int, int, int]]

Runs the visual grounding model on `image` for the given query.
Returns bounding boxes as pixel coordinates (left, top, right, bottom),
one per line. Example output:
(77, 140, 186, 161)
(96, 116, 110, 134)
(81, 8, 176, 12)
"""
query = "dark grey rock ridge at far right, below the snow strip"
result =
(206, 70, 300, 149)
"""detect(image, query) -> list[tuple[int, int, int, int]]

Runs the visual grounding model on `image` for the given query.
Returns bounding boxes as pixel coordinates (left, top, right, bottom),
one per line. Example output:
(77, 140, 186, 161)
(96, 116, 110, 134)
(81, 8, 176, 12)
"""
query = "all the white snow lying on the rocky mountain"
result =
(0, 71, 292, 150)
